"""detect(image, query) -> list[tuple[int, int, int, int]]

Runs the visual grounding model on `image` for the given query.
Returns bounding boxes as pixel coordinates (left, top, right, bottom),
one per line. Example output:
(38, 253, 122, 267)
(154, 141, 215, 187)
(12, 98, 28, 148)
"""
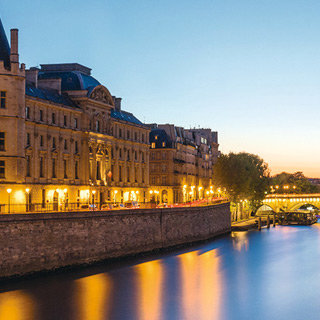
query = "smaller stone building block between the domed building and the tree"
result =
(150, 124, 219, 203)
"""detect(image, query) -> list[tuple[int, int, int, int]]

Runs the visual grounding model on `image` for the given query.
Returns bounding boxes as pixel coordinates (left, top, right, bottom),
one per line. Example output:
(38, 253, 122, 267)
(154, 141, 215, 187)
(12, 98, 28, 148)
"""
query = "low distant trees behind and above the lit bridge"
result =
(271, 171, 319, 194)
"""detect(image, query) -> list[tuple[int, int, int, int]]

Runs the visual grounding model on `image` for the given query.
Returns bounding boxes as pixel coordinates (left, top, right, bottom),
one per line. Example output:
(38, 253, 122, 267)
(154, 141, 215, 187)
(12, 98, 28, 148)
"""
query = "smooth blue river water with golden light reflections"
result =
(0, 224, 320, 320)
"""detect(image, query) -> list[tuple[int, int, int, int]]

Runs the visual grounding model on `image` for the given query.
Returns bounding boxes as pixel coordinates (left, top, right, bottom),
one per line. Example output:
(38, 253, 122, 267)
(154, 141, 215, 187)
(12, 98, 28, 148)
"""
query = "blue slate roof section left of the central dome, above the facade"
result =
(26, 83, 79, 108)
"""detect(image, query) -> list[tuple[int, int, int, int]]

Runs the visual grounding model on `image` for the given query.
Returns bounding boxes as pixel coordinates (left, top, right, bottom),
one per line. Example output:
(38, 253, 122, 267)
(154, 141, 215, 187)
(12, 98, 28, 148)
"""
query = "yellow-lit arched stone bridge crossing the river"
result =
(257, 193, 320, 212)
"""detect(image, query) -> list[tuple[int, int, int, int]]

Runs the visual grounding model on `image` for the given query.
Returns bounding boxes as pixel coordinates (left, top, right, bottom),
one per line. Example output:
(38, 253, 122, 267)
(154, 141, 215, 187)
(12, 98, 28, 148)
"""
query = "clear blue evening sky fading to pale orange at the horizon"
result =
(0, 0, 320, 177)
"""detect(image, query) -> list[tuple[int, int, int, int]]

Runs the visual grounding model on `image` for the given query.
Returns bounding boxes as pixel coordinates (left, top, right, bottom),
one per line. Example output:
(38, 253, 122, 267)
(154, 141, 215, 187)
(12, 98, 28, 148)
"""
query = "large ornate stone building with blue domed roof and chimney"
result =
(0, 21, 150, 212)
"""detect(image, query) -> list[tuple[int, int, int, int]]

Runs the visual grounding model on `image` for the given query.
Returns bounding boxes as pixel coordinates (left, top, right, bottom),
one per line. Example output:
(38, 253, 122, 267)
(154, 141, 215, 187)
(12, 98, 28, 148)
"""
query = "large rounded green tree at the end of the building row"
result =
(213, 152, 269, 204)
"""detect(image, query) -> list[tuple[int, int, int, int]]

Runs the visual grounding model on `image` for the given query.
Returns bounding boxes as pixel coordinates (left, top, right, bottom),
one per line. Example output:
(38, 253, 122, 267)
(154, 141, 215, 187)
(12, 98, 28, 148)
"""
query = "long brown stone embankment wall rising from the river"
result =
(0, 203, 231, 278)
